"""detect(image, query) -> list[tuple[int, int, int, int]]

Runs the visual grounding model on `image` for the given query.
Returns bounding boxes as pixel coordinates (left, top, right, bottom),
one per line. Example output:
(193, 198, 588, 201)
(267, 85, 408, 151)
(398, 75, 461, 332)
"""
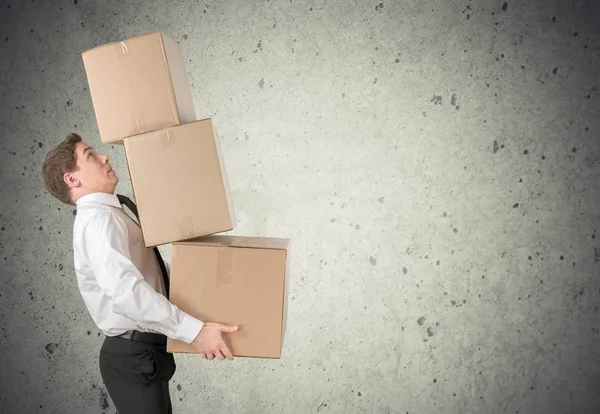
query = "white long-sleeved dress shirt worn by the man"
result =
(73, 193, 204, 343)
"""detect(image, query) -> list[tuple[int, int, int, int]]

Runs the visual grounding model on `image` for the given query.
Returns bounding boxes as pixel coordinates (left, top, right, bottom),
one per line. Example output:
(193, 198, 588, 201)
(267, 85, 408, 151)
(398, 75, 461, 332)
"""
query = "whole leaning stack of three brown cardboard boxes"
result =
(82, 33, 289, 358)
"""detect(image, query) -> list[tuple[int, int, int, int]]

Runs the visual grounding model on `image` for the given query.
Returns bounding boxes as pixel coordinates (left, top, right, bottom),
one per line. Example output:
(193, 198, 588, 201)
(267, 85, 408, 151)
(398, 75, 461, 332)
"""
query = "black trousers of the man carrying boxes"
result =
(100, 337, 176, 414)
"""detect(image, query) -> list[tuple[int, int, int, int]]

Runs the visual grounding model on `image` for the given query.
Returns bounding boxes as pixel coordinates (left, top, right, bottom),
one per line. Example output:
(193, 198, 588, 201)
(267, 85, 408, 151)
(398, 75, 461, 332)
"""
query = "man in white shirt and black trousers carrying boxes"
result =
(42, 134, 238, 414)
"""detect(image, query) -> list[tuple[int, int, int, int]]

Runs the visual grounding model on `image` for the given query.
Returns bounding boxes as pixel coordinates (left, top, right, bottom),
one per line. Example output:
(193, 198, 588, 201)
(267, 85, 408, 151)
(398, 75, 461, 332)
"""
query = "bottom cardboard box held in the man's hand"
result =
(167, 236, 290, 358)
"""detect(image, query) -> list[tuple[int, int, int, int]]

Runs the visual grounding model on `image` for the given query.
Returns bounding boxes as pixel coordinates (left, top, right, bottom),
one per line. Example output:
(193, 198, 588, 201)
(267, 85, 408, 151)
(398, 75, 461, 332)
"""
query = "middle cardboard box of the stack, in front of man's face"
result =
(124, 119, 236, 247)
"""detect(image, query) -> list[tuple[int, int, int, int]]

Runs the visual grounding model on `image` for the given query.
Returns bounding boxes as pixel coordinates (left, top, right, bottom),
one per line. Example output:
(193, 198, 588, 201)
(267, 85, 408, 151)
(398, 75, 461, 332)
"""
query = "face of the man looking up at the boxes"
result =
(65, 142, 119, 193)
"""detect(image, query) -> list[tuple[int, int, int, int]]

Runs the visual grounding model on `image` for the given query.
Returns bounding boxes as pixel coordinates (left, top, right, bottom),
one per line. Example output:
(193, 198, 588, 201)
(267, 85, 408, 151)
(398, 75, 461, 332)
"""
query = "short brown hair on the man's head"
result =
(42, 133, 82, 204)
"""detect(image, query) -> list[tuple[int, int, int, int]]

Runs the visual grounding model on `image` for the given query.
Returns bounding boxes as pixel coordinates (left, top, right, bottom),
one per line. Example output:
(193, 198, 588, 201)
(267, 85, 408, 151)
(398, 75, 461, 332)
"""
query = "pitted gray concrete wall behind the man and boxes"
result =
(0, 0, 600, 414)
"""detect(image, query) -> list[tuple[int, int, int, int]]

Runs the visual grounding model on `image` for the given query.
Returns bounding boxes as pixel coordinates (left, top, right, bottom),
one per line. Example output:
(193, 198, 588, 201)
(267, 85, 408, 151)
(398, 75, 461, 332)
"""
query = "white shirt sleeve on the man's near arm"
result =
(83, 212, 204, 343)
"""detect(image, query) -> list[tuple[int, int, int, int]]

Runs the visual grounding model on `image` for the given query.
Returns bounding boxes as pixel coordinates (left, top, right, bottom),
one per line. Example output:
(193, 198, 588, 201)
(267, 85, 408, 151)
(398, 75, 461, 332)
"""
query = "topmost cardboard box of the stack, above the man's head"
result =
(82, 32, 196, 144)
